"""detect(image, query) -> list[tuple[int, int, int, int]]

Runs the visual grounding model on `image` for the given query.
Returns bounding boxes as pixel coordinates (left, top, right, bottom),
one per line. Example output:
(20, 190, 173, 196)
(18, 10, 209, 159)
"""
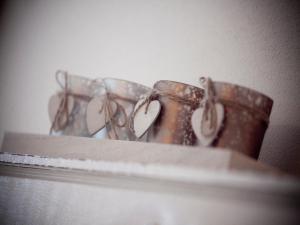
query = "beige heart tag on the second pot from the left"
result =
(86, 95, 118, 135)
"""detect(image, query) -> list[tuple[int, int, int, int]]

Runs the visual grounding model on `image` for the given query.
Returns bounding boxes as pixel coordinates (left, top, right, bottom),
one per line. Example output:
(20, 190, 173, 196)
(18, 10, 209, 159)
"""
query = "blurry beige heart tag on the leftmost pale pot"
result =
(48, 94, 75, 130)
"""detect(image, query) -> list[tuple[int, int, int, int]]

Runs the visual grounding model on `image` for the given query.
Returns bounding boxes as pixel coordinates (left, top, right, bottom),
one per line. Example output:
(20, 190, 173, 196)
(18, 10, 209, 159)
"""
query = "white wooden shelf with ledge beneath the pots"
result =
(0, 133, 300, 225)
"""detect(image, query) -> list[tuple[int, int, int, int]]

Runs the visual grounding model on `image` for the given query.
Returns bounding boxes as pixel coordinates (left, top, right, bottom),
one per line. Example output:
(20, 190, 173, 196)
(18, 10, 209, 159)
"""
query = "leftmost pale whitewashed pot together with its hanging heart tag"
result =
(48, 71, 105, 137)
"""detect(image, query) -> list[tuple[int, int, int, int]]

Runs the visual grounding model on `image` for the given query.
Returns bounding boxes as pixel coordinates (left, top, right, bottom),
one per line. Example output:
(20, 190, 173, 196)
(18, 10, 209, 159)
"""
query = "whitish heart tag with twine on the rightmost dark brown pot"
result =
(192, 103, 224, 146)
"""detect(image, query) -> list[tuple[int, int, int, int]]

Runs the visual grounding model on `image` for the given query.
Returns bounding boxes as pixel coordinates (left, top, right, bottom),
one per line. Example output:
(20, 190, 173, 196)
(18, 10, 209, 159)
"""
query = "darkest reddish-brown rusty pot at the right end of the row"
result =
(213, 82, 273, 159)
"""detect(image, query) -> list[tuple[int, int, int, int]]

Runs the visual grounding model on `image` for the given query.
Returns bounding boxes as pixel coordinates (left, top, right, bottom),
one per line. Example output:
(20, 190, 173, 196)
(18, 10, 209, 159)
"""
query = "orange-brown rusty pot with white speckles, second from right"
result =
(148, 80, 204, 145)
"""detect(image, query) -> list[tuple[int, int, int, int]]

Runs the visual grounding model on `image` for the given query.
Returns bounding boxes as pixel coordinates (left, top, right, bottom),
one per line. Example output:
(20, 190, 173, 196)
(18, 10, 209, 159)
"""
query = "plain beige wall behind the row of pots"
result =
(0, 0, 300, 174)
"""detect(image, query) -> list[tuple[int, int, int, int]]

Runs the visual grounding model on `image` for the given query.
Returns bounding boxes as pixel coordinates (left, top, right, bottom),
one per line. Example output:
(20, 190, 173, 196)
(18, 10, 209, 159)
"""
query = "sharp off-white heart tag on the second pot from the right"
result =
(133, 98, 161, 138)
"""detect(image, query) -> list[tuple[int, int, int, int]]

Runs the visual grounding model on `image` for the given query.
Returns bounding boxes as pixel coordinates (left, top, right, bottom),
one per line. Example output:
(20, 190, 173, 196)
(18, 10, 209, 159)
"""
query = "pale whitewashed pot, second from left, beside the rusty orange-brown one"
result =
(103, 78, 152, 141)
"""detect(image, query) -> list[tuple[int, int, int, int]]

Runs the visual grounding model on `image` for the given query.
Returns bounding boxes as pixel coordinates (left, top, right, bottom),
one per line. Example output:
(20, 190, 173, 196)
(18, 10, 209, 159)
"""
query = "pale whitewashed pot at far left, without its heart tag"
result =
(49, 71, 105, 137)
